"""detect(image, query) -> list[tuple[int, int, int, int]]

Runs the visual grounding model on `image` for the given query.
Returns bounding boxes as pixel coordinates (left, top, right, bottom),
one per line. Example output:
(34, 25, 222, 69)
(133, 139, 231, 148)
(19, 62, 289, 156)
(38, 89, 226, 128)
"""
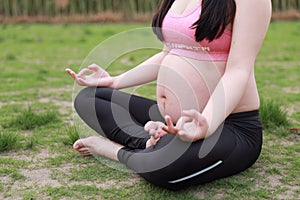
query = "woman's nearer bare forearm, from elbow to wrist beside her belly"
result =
(202, 69, 250, 137)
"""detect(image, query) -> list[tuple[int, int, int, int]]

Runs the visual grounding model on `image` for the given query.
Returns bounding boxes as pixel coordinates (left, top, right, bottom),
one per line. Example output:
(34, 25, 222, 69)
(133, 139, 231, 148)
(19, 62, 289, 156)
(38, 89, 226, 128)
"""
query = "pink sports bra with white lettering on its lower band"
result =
(162, 1, 231, 61)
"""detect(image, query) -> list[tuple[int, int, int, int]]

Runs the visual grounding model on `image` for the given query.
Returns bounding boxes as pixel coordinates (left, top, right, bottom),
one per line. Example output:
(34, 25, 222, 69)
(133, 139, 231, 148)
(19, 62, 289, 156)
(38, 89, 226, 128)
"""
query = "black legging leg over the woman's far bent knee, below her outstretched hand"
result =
(74, 87, 163, 149)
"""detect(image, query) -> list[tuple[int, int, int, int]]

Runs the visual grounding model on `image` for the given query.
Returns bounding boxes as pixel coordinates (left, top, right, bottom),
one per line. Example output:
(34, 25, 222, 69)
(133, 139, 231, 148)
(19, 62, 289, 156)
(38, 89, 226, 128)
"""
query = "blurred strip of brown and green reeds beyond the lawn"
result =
(0, 0, 300, 23)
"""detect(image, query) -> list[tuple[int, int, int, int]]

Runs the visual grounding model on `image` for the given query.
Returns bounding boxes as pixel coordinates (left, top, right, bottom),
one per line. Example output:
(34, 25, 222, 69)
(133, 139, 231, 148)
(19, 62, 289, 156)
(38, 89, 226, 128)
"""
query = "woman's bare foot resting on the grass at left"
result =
(73, 136, 123, 160)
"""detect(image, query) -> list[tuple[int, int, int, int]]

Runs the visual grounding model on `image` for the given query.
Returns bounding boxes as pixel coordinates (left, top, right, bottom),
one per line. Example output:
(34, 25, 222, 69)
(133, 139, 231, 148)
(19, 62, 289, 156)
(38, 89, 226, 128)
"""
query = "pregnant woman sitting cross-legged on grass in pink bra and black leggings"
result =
(66, 0, 271, 190)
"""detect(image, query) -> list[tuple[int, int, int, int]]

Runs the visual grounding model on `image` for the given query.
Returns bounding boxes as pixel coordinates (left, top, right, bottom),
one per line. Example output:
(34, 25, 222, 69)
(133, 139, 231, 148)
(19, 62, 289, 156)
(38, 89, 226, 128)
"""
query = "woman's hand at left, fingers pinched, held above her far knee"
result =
(66, 64, 114, 88)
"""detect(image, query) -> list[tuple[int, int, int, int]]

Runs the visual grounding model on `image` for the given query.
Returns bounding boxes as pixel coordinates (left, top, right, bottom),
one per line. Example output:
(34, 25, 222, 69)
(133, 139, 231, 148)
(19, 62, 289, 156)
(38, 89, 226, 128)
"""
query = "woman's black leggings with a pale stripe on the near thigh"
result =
(75, 87, 262, 190)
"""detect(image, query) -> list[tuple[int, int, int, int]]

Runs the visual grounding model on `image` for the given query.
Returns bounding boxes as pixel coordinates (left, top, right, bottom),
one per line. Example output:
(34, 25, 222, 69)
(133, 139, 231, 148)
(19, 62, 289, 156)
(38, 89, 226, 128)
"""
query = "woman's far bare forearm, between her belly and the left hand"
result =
(113, 51, 167, 89)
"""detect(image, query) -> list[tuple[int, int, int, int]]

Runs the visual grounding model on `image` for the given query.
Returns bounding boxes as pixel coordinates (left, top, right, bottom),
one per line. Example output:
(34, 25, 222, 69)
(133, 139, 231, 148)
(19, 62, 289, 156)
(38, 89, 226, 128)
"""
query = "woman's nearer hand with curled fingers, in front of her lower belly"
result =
(162, 110, 208, 142)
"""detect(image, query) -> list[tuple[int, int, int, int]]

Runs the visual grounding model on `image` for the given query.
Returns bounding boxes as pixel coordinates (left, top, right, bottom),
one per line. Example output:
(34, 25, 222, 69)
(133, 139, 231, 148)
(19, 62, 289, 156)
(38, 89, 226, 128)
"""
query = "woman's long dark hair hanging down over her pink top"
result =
(152, 0, 236, 41)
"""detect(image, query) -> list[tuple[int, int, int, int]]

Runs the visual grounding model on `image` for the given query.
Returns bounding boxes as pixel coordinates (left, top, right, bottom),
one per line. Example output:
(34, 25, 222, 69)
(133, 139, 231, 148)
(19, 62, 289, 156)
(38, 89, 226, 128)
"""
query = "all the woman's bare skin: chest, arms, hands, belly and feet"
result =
(66, 0, 271, 160)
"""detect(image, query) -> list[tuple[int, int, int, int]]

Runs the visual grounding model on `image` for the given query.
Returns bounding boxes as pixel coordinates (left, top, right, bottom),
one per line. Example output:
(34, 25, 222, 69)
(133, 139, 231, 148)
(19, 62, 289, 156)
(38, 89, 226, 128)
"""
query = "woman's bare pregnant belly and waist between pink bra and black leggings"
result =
(156, 54, 259, 123)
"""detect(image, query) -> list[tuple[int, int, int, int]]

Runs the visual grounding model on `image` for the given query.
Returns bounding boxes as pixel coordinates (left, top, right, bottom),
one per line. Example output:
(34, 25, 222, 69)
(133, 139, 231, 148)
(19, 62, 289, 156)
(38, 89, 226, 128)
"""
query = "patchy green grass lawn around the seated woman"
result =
(0, 21, 300, 200)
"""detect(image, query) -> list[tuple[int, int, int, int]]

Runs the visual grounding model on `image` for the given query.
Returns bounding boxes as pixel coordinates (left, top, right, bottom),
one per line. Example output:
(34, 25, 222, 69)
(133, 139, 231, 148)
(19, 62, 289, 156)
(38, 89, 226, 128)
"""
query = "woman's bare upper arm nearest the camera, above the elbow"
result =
(228, 0, 272, 65)
